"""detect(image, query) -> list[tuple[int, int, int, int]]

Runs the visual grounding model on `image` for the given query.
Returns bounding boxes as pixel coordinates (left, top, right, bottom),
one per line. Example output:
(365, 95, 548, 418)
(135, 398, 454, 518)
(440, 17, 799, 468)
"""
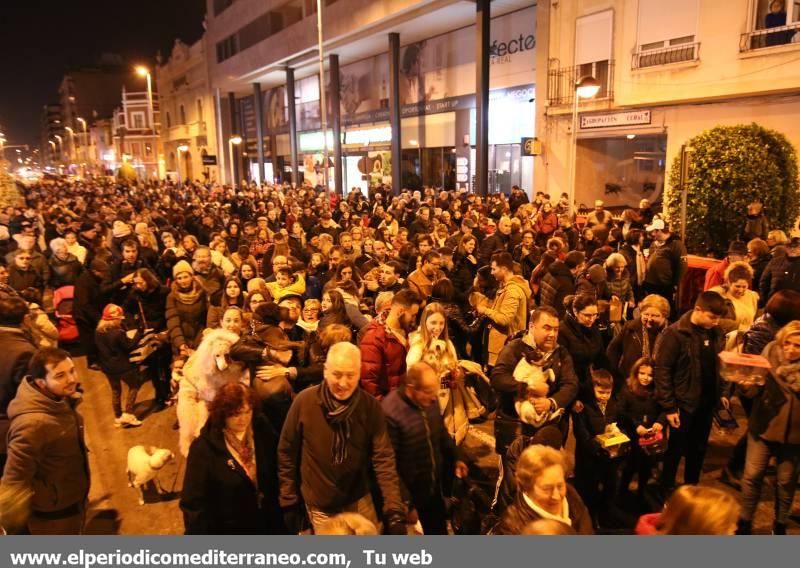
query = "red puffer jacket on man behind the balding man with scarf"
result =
(359, 320, 408, 400)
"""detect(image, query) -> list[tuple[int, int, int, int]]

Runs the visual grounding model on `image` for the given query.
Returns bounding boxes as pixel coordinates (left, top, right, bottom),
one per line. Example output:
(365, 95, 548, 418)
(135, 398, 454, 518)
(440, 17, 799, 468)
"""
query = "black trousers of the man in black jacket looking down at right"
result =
(661, 405, 713, 489)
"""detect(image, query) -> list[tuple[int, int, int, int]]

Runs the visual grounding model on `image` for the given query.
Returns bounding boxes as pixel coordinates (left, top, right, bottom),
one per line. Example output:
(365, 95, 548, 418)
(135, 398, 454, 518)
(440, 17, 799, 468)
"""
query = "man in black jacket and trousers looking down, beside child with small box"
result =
(654, 291, 730, 493)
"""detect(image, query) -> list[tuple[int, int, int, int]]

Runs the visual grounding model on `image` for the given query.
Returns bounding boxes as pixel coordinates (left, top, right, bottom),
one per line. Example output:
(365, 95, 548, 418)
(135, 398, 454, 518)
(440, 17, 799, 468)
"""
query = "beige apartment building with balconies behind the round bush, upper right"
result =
(535, 0, 800, 207)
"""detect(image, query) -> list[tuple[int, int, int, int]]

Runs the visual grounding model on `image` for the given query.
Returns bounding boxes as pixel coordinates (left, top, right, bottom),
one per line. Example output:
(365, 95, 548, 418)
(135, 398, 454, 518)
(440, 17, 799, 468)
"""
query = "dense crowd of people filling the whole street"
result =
(0, 181, 800, 534)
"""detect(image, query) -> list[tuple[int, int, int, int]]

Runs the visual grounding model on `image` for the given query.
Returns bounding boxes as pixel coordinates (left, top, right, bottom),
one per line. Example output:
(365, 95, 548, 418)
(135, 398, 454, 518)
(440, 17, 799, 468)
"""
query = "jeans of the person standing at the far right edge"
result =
(741, 434, 800, 524)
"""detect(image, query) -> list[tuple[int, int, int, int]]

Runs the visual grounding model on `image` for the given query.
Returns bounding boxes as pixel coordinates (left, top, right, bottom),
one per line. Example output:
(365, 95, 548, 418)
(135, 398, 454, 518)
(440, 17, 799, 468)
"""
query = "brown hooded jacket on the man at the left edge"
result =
(3, 379, 89, 513)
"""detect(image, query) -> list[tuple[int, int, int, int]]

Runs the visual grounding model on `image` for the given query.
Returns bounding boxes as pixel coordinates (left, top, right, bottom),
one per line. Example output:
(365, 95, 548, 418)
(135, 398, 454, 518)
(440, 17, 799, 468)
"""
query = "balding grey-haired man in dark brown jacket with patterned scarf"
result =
(278, 342, 406, 534)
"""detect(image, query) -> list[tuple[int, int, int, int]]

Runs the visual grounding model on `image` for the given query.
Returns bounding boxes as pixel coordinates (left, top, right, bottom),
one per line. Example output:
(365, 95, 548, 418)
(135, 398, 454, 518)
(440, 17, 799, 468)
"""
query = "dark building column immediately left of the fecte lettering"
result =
(474, 0, 491, 195)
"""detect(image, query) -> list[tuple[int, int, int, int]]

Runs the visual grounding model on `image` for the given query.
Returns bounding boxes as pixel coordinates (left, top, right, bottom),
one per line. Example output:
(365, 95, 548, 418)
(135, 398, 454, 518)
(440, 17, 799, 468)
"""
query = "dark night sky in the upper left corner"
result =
(0, 0, 206, 144)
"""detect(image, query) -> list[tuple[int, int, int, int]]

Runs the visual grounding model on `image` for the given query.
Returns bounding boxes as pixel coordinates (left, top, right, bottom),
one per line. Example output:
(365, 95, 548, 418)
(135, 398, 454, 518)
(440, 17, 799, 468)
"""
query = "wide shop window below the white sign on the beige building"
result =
(575, 134, 667, 208)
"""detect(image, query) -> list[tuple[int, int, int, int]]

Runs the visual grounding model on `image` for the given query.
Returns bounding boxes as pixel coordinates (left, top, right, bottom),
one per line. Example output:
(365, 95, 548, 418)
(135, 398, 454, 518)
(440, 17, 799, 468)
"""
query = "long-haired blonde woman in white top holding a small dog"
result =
(406, 302, 484, 444)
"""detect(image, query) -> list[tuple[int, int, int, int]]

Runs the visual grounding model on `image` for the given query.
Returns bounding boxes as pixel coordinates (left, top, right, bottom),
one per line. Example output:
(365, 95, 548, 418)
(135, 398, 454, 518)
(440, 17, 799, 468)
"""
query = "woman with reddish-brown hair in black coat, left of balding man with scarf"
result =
(180, 383, 286, 534)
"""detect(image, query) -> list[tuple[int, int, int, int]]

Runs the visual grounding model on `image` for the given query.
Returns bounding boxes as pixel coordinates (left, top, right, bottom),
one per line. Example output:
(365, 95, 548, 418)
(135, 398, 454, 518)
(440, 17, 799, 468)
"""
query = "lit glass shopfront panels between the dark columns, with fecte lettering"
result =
(238, 7, 536, 193)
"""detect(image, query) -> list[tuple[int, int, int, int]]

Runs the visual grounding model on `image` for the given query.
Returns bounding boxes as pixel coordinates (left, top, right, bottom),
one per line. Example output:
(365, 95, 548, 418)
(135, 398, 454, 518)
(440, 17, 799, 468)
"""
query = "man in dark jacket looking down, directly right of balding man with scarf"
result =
(382, 363, 468, 535)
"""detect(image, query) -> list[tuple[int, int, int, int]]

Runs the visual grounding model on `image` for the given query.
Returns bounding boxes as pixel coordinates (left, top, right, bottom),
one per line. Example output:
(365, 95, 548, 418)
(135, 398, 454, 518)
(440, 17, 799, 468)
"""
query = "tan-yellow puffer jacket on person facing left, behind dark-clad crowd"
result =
(484, 275, 532, 366)
